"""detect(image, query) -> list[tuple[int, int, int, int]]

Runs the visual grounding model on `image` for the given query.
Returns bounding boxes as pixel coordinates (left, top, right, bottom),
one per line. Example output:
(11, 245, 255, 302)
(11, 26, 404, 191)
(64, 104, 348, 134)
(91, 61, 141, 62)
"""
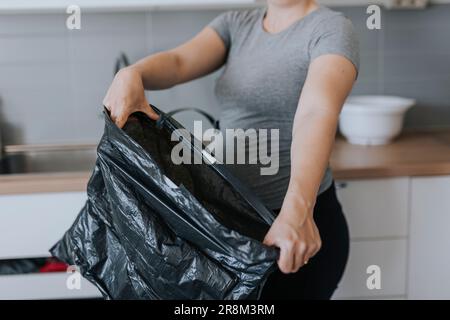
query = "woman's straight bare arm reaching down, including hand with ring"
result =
(265, 55, 356, 273)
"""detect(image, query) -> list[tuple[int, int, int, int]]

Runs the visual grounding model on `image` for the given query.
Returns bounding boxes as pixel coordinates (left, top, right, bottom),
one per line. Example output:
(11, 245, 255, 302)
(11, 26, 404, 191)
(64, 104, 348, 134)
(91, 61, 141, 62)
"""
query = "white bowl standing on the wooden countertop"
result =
(339, 96, 415, 145)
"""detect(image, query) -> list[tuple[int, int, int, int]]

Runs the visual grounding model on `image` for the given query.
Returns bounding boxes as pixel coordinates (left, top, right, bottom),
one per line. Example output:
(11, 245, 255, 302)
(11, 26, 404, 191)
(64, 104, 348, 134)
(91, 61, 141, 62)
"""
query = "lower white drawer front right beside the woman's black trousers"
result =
(333, 240, 407, 299)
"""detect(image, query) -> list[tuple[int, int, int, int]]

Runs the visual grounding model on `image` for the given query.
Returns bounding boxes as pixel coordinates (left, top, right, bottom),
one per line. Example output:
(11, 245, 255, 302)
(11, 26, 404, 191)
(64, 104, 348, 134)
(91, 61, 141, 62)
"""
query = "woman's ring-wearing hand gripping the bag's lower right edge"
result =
(264, 198, 322, 273)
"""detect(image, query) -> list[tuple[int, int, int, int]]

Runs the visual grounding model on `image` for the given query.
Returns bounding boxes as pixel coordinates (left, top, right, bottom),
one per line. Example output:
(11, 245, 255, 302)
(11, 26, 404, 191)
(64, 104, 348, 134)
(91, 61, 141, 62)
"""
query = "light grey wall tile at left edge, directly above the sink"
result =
(0, 63, 73, 144)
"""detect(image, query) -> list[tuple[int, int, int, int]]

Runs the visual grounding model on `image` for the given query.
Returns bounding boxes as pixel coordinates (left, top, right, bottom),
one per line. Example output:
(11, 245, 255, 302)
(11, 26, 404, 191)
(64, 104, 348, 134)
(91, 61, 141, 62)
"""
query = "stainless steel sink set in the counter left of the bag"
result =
(0, 145, 96, 174)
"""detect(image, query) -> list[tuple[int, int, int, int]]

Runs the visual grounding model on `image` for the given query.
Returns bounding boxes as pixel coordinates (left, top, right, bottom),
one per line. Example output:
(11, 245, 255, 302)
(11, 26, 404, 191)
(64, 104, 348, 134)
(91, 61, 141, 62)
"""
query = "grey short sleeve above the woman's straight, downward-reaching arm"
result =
(309, 15, 360, 73)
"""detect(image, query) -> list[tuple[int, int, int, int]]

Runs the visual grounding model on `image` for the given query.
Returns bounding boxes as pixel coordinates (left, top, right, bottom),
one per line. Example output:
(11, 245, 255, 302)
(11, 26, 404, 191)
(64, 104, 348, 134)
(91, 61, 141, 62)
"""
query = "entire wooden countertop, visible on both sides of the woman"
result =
(0, 129, 450, 195)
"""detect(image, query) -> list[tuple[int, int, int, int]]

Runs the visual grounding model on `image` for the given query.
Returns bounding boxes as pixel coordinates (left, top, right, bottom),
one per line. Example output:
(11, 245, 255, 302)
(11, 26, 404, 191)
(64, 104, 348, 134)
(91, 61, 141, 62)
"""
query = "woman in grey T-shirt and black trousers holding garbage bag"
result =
(104, 0, 358, 299)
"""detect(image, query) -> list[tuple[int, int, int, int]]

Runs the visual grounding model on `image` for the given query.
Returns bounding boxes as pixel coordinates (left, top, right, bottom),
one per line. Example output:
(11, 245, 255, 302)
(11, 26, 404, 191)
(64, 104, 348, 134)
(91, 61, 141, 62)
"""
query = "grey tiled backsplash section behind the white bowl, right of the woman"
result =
(341, 5, 450, 127)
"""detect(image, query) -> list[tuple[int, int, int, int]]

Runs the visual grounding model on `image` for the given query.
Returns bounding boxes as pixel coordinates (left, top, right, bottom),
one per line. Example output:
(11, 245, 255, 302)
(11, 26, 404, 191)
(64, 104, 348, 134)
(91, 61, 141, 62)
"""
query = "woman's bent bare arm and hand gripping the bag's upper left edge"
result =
(103, 27, 226, 127)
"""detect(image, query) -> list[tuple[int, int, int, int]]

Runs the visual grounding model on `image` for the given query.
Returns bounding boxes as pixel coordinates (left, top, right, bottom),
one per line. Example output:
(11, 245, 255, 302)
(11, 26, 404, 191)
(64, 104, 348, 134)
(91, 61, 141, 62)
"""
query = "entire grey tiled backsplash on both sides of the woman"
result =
(0, 5, 450, 144)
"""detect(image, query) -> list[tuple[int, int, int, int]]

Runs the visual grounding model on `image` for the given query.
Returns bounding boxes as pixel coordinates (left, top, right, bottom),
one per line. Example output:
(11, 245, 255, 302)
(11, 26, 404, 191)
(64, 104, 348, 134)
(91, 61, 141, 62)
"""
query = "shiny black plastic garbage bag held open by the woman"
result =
(50, 108, 278, 299)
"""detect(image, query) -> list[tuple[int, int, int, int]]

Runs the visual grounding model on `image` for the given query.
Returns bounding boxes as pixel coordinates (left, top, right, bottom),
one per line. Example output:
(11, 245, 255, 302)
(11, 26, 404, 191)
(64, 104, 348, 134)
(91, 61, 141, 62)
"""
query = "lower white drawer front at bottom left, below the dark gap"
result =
(0, 272, 102, 300)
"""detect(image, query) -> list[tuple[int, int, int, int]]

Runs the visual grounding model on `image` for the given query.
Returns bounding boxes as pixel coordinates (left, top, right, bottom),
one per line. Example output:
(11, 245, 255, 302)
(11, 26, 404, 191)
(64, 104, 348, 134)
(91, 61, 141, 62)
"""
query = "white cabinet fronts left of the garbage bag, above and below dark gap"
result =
(0, 192, 101, 300)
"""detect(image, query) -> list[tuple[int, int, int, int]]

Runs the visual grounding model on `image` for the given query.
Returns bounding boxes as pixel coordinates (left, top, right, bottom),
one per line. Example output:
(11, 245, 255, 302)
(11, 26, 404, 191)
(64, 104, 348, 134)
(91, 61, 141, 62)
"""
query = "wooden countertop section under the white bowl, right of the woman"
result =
(331, 129, 450, 180)
